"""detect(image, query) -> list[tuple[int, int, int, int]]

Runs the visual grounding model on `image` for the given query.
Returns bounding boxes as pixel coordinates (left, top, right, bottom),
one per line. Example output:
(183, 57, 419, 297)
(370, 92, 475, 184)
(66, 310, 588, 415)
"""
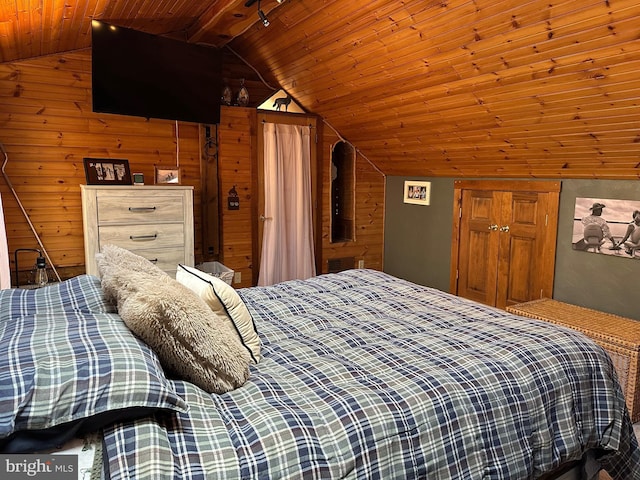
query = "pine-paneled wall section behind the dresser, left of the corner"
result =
(0, 50, 201, 283)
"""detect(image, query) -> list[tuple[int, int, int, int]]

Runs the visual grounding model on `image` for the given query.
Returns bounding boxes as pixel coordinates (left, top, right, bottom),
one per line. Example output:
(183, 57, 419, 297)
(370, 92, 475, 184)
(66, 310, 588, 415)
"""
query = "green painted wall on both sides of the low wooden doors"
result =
(384, 177, 640, 320)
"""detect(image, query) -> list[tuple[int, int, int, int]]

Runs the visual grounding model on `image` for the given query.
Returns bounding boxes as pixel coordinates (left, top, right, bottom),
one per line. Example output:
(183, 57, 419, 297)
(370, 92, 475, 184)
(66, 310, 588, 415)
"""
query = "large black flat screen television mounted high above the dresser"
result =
(91, 21, 222, 124)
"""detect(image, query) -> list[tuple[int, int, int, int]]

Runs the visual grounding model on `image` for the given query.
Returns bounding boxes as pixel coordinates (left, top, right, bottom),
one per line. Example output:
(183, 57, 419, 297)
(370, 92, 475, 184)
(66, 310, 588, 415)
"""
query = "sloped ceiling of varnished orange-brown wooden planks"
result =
(0, 0, 640, 178)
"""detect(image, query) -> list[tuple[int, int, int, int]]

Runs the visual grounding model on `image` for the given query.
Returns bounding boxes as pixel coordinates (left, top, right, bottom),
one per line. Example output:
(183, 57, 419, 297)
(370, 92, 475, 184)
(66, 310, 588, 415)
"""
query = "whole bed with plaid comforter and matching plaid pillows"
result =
(0, 269, 640, 480)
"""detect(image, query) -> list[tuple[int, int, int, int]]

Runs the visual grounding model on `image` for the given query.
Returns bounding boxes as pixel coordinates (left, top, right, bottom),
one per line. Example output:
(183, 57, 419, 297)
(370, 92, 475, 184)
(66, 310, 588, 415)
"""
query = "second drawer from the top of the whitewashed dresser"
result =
(98, 223, 184, 251)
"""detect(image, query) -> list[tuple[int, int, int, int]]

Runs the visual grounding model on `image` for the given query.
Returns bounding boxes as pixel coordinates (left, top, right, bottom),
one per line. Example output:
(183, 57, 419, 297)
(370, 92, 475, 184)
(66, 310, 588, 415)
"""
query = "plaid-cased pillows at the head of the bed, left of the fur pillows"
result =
(0, 275, 187, 453)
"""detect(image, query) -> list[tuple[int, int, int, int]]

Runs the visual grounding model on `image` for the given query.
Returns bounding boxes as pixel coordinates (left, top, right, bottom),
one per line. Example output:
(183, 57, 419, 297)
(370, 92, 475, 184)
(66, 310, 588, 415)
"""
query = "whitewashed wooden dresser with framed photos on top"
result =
(80, 185, 194, 277)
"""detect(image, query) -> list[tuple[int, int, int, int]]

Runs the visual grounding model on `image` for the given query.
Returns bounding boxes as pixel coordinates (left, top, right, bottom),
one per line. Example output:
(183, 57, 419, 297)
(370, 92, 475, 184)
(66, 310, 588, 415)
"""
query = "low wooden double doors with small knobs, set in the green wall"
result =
(451, 181, 560, 308)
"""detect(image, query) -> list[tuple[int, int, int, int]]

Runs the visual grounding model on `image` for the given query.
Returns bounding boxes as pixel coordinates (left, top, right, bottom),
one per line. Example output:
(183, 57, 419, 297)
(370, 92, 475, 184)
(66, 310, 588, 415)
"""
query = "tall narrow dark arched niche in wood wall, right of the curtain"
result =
(331, 141, 356, 242)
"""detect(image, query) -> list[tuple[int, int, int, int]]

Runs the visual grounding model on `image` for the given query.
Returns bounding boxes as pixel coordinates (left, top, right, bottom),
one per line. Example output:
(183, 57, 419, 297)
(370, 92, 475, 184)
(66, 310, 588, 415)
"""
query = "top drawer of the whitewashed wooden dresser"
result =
(97, 195, 184, 225)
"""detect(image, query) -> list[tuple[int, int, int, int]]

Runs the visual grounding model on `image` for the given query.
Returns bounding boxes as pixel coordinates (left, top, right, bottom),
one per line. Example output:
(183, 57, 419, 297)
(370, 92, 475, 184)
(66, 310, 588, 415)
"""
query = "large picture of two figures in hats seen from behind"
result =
(571, 198, 640, 260)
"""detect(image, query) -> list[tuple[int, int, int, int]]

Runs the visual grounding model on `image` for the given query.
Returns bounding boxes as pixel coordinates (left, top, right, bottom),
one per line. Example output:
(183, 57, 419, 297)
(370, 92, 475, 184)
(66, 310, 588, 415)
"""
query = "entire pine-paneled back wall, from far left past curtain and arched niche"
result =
(0, 50, 384, 287)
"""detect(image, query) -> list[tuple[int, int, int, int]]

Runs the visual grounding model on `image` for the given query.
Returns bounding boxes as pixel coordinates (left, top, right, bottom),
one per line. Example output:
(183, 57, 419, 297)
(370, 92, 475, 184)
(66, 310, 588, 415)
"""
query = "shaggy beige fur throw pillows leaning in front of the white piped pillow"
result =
(98, 248, 250, 393)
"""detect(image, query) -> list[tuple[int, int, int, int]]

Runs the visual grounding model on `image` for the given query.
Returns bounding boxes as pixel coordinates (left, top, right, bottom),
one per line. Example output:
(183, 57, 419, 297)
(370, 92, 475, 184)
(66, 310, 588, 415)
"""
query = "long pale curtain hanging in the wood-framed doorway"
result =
(258, 123, 316, 285)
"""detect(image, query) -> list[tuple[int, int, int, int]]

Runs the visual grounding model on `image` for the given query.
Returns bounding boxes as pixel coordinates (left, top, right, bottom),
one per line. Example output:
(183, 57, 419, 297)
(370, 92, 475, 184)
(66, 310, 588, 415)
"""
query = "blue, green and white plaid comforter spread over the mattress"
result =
(94, 270, 640, 480)
